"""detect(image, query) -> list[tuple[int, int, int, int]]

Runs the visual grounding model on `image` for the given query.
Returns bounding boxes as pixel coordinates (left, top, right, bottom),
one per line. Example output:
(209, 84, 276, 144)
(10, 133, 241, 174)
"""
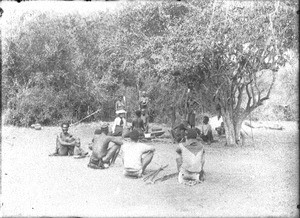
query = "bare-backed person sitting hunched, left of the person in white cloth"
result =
(88, 124, 123, 169)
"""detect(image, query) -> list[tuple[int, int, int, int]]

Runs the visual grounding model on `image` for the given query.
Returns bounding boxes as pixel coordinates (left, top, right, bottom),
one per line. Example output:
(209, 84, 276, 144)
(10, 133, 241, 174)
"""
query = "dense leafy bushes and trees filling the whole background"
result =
(2, 1, 298, 144)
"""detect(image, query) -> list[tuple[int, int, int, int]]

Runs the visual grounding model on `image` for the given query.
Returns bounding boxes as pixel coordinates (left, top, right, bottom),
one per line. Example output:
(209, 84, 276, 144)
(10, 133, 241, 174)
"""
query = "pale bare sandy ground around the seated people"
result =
(1, 122, 299, 217)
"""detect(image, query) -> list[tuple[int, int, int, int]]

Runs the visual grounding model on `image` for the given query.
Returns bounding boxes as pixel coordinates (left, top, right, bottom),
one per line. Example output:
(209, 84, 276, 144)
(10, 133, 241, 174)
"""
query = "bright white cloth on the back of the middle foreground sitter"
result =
(121, 142, 152, 170)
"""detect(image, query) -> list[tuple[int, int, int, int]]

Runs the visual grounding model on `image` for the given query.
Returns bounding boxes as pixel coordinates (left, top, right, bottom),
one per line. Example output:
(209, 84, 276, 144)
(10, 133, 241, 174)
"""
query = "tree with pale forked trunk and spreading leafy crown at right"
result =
(169, 1, 297, 145)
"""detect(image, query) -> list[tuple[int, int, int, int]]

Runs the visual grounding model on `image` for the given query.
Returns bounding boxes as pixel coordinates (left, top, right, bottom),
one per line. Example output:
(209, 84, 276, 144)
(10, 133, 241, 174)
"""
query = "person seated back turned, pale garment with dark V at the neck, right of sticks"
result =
(176, 129, 205, 185)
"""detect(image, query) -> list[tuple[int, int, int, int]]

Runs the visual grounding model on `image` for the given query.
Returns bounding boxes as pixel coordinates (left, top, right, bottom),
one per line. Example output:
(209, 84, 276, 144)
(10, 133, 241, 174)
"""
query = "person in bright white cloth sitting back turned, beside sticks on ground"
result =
(122, 130, 155, 178)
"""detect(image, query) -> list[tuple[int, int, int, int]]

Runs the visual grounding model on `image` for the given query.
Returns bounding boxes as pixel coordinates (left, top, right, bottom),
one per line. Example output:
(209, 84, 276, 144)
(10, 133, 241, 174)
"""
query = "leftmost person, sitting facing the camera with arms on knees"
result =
(50, 122, 88, 156)
